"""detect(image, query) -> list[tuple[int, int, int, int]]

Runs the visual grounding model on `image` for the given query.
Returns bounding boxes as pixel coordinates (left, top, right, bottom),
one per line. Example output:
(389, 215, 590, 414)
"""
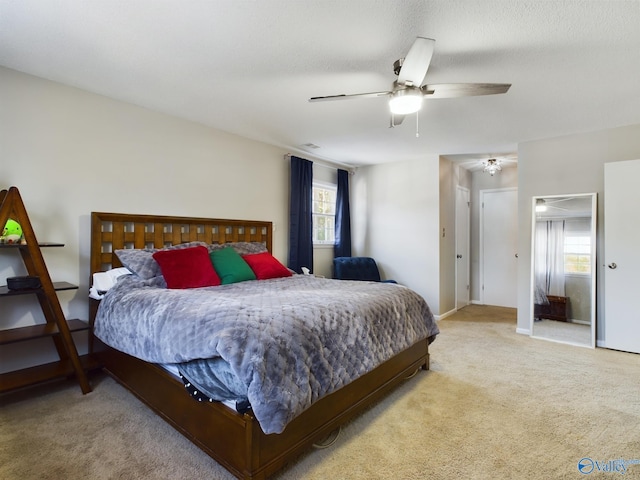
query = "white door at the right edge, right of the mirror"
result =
(602, 160, 640, 353)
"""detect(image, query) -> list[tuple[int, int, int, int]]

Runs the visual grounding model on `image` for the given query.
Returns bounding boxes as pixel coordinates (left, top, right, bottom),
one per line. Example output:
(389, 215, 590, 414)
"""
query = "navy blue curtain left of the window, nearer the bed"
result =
(288, 156, 313, 273)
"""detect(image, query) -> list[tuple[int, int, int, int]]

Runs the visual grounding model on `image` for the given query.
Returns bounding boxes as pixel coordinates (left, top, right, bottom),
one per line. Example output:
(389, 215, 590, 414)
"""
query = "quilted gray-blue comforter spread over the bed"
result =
(95, 275, 438, 434)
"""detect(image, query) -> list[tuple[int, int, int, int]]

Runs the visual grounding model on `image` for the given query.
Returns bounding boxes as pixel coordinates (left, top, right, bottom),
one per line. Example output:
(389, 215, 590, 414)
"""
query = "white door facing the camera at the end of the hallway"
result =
(480, 188, 518, 308)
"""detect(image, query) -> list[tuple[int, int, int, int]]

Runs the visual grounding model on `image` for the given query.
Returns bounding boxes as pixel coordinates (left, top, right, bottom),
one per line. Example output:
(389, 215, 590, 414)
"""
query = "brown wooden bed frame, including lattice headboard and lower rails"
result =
(89, 212, 429, 479)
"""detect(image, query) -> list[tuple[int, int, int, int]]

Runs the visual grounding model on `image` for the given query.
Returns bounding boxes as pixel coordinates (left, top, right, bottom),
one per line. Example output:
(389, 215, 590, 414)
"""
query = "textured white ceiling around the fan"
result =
(0, 0, 640, 165)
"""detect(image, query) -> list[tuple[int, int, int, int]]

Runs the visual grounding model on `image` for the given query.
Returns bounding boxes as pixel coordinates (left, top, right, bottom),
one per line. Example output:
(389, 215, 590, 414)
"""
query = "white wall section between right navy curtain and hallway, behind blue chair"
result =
(351, 156, 440, 314)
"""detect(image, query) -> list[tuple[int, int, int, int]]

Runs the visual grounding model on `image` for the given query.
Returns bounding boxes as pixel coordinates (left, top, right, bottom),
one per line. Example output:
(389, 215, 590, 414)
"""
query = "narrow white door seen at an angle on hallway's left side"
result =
(456, 186, 471, 310)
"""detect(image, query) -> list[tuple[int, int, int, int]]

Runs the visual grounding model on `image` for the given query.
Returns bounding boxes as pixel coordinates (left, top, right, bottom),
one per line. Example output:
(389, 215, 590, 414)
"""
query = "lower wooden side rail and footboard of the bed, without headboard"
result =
(94, 339, 429, 480)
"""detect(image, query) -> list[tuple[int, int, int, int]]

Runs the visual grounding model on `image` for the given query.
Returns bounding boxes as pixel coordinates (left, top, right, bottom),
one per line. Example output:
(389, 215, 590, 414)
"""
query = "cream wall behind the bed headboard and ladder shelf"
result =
(0, 68, 289, 370)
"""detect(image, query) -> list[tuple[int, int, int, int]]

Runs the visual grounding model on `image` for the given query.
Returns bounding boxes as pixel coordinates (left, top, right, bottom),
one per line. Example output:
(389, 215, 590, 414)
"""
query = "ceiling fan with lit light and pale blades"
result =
(309, 37, 511, 127)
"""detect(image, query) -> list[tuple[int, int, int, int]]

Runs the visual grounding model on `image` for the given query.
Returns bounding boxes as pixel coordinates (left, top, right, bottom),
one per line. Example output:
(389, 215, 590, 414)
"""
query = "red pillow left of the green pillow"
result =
(153, 245, 221, 288)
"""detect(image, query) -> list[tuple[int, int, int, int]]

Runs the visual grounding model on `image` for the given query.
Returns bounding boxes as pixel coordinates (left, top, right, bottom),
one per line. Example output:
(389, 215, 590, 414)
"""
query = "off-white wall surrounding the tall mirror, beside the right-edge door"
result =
(518, 124, 640, 339)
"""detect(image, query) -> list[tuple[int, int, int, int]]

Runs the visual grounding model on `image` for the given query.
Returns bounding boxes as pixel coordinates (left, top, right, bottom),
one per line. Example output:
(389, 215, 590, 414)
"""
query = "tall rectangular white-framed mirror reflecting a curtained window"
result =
(531, 193, 596, 348)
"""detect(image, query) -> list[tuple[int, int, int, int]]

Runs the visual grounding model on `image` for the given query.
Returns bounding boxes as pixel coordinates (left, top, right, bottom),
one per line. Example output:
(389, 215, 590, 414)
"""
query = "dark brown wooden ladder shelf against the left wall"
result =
(0, 187, 91, 393)
